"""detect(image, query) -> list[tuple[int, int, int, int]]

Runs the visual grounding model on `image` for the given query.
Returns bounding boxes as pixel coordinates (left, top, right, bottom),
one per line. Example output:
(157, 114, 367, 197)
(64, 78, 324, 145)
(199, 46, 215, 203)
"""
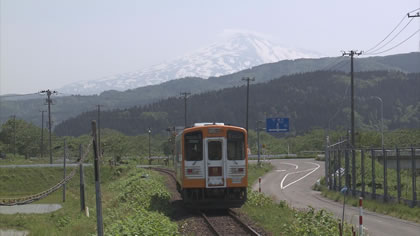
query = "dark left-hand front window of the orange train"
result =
(185, 131, 203, 161)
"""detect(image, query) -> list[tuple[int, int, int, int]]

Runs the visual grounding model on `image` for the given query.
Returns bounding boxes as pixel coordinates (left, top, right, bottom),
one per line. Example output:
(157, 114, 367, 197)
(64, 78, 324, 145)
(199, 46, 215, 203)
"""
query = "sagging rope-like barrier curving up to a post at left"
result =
(0, 139, 93, 206)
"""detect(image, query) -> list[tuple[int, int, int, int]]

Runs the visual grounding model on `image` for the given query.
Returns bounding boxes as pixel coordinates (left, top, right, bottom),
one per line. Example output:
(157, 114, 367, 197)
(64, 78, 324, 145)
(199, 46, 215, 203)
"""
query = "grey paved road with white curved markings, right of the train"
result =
(253, 159, 420, 236)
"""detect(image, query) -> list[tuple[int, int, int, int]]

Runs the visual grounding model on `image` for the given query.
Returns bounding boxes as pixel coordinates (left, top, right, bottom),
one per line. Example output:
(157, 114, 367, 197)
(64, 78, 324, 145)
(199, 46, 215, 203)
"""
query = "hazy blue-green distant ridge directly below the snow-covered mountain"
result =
(0, 52, 420, 126)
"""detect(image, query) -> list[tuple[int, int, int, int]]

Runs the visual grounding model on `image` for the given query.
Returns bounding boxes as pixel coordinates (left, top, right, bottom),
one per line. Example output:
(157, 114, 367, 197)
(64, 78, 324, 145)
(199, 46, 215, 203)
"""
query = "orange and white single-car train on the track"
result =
(174, 123, 248, 208)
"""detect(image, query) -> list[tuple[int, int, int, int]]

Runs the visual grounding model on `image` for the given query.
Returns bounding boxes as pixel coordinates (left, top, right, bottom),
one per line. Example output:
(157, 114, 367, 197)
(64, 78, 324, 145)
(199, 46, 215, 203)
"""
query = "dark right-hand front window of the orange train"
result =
(227, 131, 245, 160)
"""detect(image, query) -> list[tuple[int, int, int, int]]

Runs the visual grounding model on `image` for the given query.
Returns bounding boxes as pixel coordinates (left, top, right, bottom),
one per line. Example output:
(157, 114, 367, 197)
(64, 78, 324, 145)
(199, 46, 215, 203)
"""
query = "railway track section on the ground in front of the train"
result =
(200, 209, 260, 236)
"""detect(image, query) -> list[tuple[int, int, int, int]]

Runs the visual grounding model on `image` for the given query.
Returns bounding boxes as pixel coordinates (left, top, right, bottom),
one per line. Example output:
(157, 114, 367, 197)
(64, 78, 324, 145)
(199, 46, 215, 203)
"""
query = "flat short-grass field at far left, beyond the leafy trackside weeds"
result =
(0, 167, 108, 235)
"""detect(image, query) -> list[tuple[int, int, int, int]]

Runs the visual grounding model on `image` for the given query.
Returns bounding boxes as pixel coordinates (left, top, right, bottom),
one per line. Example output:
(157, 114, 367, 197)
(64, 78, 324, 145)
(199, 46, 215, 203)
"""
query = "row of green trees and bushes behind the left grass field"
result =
(0, 119, 170, 165)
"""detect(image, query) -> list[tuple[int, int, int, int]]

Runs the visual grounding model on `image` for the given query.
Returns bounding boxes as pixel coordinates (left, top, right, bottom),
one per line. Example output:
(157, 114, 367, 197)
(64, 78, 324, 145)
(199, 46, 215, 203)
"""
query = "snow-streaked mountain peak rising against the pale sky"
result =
(59, 32, 322, 95)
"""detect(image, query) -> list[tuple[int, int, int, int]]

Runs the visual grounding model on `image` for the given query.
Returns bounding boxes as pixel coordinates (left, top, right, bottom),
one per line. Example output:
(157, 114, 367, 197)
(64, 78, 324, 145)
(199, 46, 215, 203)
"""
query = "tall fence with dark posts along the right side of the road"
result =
(326, 146, 420, 207)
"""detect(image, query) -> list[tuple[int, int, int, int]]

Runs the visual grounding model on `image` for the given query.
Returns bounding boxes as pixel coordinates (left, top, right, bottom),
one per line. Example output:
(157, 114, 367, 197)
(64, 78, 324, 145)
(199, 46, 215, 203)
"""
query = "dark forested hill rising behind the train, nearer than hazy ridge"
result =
(55, 71, 420, 136)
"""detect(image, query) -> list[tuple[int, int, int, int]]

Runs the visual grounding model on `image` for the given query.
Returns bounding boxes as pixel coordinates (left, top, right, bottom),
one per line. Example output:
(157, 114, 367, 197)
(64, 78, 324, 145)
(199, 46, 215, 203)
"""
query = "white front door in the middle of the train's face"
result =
(204, 138, 226, 188)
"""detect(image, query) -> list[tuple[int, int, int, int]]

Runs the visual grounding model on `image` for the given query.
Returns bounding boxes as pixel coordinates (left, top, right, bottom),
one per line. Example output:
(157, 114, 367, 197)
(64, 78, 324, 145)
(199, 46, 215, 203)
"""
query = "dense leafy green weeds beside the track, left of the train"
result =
(105, 169, 178, 235)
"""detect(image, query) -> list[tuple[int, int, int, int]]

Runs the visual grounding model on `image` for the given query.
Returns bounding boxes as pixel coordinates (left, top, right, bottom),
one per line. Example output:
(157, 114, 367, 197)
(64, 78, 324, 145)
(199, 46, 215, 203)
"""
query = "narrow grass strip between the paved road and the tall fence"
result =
(320, 186, 420, 223)
